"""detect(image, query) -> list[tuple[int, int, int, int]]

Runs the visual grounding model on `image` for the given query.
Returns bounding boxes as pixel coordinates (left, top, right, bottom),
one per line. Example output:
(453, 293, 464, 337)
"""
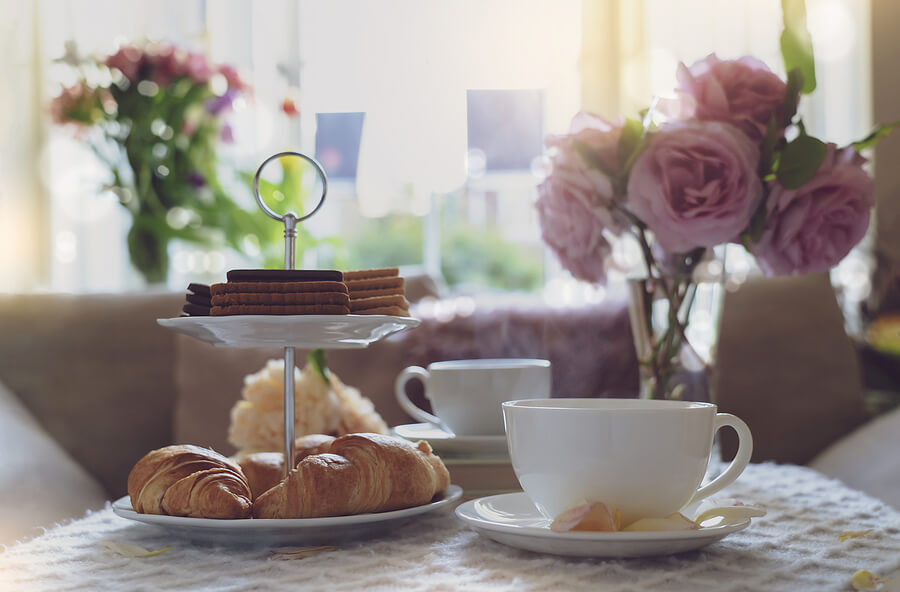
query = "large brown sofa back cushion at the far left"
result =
(0, 293, 184, 497)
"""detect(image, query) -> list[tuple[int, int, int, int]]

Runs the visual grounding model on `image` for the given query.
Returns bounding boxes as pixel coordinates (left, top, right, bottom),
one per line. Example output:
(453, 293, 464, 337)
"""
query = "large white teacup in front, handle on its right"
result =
(503, 399, 753, 525)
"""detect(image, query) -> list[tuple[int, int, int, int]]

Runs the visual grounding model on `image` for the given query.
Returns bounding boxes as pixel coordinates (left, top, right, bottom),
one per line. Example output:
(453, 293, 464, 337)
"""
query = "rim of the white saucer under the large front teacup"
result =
(456, 492, 750, 543)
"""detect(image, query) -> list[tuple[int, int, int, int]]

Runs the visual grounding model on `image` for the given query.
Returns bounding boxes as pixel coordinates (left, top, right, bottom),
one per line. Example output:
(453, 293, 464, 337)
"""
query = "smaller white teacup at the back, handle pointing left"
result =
(394, 358, 550, 436)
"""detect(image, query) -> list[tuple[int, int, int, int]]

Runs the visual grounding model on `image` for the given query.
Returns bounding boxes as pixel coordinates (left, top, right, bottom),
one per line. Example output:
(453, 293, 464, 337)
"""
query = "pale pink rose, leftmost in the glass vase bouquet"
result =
(536, 113, 623, 282)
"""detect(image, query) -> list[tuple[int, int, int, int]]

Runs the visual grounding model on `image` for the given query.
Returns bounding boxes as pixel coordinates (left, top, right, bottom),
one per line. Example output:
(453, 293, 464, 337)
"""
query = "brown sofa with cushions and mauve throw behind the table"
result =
(0, 276, 900, 544)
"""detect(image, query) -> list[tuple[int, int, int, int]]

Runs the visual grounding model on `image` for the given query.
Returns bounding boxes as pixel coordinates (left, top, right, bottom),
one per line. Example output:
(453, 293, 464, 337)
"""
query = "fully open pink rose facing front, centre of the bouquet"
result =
(628, 121, 763, 253)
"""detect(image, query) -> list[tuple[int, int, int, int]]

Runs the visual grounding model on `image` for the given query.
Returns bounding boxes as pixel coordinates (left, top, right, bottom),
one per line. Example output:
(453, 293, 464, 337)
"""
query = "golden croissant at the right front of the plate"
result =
(253, 434, 450, 518)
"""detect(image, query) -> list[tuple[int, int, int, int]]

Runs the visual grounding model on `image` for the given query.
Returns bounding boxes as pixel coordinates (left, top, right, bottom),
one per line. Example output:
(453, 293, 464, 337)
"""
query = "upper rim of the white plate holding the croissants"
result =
(112, 485, 462, 531)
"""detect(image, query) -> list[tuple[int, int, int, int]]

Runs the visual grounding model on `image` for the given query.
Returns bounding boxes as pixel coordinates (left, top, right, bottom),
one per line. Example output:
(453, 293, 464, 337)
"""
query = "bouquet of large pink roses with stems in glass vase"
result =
(536, 18, 890, 398)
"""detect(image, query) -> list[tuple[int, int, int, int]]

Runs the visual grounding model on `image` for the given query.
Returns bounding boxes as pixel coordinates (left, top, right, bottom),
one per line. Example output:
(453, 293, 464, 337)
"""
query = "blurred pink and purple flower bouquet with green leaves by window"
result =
(50, 43, 264, 282)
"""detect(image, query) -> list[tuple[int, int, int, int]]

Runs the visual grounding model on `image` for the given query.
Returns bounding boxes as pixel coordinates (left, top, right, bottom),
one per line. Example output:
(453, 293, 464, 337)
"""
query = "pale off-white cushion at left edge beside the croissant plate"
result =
(0, 383, 106, 545)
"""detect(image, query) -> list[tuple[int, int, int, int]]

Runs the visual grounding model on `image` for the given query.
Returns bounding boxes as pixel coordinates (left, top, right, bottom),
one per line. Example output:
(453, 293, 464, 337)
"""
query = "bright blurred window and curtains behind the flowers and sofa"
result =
(0, 0, 898, 314)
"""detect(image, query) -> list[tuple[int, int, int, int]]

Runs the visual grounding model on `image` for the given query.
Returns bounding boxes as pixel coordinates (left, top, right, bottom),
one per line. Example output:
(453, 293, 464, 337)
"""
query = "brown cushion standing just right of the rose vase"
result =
(714, 274, 865, 464)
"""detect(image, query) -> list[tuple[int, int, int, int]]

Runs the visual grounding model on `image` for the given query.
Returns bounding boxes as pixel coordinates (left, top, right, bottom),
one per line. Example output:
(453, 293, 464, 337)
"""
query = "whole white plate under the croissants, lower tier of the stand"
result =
(112, 485, 462, 545)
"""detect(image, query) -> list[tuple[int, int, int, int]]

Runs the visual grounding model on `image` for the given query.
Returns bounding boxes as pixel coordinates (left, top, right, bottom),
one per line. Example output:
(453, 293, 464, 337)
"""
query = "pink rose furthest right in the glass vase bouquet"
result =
(751, 144, 875, 275)
